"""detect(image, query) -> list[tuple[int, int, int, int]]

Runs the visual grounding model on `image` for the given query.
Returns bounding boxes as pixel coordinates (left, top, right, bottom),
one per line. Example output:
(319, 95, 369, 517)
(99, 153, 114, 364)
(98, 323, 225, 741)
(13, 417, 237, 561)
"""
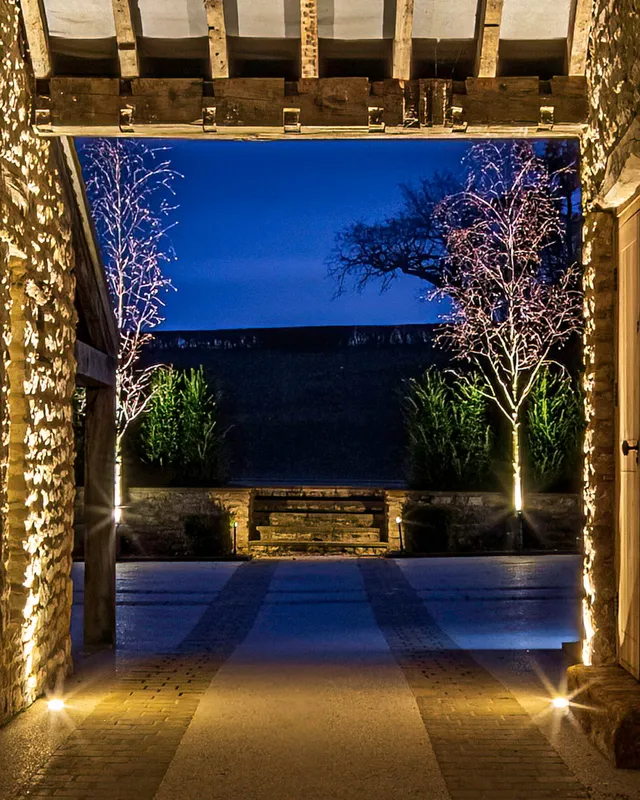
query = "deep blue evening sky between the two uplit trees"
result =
(152, 140, 469, 330)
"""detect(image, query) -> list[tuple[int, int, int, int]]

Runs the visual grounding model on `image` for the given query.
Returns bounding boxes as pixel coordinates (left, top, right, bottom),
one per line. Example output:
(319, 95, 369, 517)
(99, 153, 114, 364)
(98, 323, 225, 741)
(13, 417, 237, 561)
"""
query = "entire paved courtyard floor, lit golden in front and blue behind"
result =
(0, 556, 640, 800)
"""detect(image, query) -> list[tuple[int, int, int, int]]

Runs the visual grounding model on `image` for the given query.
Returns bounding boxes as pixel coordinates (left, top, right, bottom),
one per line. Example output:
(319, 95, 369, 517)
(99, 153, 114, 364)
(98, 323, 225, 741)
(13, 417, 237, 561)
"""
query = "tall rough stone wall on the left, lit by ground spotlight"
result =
(0, 0, 75, 723)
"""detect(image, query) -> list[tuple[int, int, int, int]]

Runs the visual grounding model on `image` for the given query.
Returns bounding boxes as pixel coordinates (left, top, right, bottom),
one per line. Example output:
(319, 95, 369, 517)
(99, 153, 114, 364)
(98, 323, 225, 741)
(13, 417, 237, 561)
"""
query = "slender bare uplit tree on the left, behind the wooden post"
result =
(81, 139, 178, 517)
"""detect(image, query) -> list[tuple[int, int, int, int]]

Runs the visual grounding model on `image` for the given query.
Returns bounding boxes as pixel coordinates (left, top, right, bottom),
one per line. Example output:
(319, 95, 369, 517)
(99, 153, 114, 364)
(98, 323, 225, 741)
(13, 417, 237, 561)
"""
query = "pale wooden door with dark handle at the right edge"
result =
(618, 203, 640, 679)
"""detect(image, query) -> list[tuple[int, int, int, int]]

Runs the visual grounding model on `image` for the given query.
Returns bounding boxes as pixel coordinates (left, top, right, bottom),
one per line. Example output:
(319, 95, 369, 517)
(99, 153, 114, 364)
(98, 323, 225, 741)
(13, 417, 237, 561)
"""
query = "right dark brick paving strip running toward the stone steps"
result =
(359, 560, 589, 800)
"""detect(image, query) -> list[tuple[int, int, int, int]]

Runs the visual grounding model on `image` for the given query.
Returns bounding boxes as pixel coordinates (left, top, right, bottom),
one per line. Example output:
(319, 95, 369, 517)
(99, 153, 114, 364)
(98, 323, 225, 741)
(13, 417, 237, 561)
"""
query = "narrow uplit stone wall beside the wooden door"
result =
(581, 0, 640, 664)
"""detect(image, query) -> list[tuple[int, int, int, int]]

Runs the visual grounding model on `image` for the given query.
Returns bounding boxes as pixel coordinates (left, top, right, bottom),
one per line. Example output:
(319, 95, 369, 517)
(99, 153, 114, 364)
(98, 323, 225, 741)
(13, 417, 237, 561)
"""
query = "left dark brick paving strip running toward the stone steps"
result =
(23, 562, 275, 800)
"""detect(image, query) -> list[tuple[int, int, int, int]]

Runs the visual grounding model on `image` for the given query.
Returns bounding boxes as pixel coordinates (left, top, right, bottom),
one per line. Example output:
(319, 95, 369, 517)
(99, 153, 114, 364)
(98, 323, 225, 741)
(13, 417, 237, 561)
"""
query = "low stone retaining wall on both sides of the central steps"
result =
(75, 487, 583, 558)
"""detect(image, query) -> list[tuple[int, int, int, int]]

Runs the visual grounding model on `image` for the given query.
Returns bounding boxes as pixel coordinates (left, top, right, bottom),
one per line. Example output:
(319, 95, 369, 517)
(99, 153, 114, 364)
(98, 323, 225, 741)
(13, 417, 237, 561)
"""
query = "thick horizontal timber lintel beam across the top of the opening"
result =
(34, 76, 587, 137)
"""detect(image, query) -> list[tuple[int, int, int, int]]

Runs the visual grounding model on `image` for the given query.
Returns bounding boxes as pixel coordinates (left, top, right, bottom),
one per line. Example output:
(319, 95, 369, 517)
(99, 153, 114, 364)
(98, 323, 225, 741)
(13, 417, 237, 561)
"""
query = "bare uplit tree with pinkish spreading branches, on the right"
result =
(430, 142, 582, 512)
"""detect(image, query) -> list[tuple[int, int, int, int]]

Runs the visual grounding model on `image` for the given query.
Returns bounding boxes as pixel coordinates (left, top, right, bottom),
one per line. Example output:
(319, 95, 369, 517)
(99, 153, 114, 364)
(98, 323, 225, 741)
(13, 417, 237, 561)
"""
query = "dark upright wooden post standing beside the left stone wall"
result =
(84, 386, 116, 647)
